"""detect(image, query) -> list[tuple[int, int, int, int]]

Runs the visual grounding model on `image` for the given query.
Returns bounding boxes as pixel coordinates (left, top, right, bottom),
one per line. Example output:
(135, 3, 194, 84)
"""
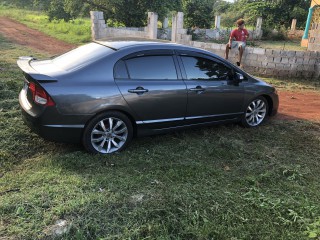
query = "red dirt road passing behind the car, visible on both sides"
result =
(0, 17, 320, 121)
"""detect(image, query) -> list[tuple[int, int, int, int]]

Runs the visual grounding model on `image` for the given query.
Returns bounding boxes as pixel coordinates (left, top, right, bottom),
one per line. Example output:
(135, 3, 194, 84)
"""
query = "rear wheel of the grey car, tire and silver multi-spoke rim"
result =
(82, 111, 133, 154)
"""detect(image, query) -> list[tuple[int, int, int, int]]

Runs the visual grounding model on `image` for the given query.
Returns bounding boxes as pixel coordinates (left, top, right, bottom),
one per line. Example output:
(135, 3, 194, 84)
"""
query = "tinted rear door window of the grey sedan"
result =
(125, 56, 177, 80)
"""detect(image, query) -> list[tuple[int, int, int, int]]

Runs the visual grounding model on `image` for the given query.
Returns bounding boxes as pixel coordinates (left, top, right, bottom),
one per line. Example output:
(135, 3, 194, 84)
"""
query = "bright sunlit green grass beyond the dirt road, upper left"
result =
(0, 5, 91, 44)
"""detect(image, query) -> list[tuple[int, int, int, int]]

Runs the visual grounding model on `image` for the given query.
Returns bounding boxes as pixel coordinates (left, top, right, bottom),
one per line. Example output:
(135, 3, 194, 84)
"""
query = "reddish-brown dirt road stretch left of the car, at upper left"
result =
(0, 17, 76, 55)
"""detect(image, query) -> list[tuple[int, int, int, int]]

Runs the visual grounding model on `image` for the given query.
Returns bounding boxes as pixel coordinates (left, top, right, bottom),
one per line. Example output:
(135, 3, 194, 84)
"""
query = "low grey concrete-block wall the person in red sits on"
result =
(184, 41, 320, 78)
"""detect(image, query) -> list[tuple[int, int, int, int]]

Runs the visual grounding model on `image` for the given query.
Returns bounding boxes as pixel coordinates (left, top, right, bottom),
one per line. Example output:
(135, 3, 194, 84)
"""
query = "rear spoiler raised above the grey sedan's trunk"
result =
(17, 56, 57, 82)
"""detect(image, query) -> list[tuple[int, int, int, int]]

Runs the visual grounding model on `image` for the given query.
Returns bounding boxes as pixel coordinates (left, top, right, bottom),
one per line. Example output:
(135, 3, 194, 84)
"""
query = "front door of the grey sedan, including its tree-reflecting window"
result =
(179, 51, 244, 122)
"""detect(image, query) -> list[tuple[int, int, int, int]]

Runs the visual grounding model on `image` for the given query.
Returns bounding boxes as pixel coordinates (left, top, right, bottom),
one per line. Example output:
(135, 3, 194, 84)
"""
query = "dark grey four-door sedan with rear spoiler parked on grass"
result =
(17, 41, 279, 154)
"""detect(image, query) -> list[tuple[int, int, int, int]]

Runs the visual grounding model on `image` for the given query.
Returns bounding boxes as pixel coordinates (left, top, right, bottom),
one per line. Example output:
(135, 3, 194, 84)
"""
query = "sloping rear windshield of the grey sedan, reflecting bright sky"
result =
(52, 43, 114, 71)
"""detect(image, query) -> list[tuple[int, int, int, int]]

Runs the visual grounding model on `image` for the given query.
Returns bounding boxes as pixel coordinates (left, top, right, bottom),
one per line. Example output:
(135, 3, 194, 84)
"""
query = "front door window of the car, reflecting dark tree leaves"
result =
(181, 56, 230, 81)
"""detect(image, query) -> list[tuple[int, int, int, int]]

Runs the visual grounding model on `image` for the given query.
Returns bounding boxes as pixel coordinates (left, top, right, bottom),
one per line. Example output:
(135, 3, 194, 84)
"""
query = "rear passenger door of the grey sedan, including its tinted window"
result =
(114, 50, 187, 127)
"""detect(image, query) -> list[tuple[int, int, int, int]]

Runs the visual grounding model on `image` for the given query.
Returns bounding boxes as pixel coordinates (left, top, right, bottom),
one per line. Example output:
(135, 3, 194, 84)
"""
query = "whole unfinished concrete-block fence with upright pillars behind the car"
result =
(91, 12, 320, 78)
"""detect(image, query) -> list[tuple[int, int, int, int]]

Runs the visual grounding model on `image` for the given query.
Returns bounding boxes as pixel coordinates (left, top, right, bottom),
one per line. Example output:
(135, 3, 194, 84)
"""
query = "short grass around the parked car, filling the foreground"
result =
(0, 31, 320, 240)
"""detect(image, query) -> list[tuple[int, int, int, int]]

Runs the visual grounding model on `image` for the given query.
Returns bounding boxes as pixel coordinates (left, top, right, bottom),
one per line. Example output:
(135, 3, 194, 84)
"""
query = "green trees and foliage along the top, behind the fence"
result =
(2, 0, 310, 29)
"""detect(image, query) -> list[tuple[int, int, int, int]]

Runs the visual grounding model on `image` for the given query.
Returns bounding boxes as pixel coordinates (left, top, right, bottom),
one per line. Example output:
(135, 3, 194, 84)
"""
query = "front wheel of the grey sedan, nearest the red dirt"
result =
(241, 96, 269, 127)
